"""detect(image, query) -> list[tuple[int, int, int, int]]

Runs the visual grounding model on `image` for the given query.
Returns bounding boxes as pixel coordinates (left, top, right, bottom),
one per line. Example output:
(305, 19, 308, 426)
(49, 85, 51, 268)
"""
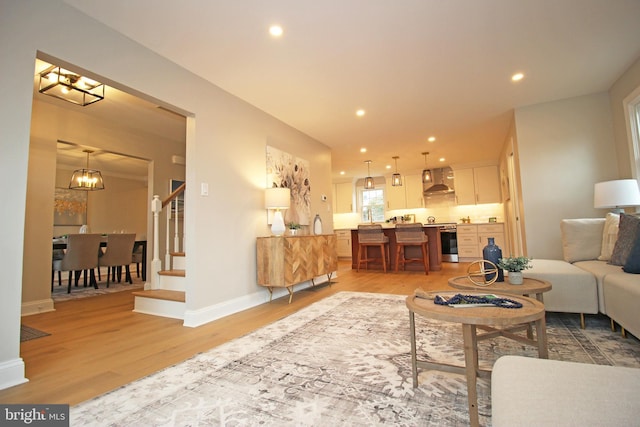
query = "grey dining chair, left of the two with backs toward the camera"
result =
(52, 234, 101, 293)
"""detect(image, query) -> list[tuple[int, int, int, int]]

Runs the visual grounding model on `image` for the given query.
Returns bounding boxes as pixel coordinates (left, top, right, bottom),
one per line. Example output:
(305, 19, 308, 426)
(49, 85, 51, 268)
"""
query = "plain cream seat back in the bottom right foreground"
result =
(491, 356, 640, 427)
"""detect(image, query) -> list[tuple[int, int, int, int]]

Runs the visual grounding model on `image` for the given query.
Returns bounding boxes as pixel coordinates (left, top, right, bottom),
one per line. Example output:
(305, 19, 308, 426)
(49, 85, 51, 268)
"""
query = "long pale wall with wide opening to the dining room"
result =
(0, 0, 333, 388)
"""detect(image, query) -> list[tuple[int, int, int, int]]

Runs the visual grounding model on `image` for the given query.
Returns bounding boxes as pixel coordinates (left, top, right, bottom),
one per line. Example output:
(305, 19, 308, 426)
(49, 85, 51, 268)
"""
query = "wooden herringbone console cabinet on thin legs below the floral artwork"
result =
(257, 234, 338, 302)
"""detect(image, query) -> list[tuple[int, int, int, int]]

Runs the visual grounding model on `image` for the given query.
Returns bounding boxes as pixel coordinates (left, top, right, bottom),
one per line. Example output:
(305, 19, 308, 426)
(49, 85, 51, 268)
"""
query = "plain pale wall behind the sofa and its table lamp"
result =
(515, 93, 618, 259)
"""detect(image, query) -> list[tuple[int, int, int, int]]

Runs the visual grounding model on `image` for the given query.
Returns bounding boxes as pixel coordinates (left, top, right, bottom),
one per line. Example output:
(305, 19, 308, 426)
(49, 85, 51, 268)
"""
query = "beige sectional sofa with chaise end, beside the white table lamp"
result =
(524, 214, 640, 337)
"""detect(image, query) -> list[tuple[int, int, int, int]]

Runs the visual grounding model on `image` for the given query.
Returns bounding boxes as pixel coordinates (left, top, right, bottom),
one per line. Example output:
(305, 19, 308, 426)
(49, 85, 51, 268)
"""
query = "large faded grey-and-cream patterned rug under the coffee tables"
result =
(70, 292, 640, 426)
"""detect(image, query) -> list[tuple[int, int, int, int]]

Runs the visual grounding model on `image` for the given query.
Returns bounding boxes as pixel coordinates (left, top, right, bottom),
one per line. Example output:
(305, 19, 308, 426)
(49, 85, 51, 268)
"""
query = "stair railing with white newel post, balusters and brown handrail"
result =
(151, 182, 187, 289)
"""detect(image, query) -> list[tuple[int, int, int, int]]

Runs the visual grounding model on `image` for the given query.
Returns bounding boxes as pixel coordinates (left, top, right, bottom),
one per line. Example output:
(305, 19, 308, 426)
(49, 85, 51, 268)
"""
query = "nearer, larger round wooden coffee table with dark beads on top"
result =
(406, 290, 548, 426)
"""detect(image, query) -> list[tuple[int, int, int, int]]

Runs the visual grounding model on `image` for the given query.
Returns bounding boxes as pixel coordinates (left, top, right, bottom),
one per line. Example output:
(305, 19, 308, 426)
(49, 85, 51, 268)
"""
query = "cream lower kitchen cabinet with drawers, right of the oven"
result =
(457, 223, 508, 262)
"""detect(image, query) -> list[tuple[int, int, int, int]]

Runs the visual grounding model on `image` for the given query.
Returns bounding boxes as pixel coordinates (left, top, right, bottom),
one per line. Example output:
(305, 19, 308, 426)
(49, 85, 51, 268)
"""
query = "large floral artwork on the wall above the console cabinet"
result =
(267, 145, 311, 225)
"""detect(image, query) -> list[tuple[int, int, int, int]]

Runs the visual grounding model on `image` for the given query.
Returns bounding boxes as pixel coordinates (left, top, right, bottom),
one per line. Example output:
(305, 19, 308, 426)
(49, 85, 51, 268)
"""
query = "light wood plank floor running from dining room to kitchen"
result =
(0, 261, 468, 405)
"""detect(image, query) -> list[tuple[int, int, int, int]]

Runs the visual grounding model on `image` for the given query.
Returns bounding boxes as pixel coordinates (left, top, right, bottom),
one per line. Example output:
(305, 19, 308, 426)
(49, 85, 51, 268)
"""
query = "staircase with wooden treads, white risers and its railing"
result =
(133, 183, 186, 320)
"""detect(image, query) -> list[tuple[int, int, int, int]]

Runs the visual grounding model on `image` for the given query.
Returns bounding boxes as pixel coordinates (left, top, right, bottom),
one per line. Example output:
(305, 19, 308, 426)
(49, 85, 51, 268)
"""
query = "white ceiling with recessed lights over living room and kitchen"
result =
(65, 0, 640, 181)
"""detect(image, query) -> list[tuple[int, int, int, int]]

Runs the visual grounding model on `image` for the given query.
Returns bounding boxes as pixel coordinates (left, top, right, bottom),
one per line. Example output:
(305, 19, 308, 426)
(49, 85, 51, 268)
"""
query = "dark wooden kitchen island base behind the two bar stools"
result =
(351, 224, 442, 271)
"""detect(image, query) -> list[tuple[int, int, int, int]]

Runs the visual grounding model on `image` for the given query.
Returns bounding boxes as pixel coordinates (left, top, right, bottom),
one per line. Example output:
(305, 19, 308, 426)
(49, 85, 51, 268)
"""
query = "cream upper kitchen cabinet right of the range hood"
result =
(454, 166, 501, 205)
